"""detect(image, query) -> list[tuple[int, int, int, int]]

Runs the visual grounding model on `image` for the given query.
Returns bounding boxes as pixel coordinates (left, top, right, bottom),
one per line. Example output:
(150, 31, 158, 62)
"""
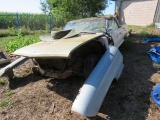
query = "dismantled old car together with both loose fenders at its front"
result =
(0, 16, 129, 116)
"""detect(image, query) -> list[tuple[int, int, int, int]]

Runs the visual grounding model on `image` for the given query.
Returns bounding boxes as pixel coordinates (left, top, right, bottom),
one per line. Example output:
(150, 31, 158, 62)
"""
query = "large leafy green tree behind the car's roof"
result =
(41, 0, 108, 21)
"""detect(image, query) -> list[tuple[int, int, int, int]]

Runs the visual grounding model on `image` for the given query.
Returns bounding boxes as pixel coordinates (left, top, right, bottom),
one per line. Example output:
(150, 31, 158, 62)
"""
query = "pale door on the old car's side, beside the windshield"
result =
(107, 19, 124, 47)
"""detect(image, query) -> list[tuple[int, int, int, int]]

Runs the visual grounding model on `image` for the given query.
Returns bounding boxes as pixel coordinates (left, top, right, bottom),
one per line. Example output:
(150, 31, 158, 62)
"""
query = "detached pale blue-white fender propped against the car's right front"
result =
(72, 46, 124, 117)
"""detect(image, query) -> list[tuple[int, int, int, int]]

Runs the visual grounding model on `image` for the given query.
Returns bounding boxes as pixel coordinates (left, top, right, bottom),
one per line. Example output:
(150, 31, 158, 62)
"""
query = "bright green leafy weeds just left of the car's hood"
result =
(5, 30, 40, 52)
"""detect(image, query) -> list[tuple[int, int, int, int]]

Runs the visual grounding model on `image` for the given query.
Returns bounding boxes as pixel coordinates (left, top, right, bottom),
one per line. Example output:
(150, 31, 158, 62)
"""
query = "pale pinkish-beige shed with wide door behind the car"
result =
(119, 0, 160, 26)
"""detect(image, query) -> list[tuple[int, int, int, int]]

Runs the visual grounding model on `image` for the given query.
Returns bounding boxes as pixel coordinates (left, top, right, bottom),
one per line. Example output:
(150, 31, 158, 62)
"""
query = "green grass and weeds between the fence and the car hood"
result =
(0, 27, 62, 52)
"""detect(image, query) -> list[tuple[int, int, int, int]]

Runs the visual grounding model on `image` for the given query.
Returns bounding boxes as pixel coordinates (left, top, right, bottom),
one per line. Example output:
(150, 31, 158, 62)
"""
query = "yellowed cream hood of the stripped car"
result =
(13, 33, 102, 58)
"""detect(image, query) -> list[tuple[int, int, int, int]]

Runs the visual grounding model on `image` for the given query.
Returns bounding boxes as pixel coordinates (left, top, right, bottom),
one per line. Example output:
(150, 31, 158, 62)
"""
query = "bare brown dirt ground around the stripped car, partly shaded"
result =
(0, 34, 160, 120)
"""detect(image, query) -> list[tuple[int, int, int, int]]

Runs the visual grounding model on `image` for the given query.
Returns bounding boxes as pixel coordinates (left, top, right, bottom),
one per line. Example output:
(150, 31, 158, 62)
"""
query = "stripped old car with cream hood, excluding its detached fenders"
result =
(9, 17, 128, 79)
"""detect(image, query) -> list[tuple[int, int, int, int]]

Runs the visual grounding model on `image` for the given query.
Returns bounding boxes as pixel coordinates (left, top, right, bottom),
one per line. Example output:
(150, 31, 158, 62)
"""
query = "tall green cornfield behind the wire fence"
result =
(0, 12, 64, 31)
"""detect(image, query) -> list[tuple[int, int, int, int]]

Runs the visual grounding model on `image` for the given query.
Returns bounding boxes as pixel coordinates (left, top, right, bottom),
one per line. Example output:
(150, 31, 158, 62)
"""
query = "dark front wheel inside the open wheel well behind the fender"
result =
(84, 54, 98, 78)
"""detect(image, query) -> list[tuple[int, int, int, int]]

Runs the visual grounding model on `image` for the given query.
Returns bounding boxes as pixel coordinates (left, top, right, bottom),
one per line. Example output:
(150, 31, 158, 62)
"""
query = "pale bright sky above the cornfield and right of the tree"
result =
(0, 0, 114, 15)
